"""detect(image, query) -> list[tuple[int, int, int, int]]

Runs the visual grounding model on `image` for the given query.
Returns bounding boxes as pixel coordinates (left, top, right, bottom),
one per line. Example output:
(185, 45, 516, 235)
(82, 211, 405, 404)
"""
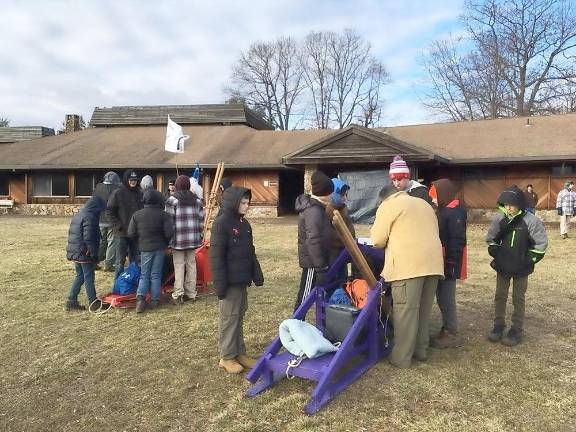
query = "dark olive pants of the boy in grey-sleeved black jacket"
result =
(494, 273, 528, 331)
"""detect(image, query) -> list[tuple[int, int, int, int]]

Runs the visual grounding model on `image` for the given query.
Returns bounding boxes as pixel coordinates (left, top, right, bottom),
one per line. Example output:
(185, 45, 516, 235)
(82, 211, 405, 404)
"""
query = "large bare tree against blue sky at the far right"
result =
(425, 0, 576, 120)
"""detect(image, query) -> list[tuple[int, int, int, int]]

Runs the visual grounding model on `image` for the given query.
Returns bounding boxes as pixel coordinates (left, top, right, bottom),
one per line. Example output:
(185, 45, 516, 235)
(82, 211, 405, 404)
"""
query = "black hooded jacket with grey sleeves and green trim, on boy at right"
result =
(486, 186, 548, 277)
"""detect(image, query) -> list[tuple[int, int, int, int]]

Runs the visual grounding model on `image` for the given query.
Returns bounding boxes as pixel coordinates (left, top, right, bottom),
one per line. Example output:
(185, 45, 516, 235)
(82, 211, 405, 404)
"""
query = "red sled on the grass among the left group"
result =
(89, 242, 214, 313)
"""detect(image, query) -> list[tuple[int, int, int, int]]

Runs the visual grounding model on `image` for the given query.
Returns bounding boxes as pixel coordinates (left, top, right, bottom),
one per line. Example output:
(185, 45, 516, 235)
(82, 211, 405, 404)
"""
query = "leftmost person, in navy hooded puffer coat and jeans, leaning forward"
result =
(65, 197, 106, 311)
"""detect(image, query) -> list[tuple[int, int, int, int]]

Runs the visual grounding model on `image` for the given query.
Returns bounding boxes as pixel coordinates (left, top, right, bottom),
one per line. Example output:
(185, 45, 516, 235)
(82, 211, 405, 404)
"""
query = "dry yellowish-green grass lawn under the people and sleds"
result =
(0, 217, 576, 432)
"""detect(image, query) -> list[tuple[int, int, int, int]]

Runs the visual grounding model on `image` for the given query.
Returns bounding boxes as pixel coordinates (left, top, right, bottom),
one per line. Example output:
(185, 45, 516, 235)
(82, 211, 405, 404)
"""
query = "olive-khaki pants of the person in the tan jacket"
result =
(390, 276, 439, 368)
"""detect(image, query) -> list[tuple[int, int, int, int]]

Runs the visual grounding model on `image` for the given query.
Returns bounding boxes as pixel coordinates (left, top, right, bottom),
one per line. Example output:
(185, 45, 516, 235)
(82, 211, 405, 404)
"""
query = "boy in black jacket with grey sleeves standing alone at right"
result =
(486, 186, 548, 346)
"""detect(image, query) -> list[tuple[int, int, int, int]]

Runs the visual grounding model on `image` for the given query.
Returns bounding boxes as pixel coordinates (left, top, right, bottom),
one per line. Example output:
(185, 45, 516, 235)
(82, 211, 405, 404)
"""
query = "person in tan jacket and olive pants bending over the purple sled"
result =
(371, 184, 444, 368)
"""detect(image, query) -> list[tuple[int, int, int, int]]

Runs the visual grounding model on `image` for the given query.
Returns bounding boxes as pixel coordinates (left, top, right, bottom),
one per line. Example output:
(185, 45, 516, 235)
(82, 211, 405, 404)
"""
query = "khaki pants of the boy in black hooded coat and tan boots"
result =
(218, 286, 248, 360)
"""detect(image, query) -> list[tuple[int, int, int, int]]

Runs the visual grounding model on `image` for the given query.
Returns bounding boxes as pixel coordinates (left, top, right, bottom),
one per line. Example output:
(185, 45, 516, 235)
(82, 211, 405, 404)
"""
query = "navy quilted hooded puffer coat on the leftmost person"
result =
(66, 197, 106, 263)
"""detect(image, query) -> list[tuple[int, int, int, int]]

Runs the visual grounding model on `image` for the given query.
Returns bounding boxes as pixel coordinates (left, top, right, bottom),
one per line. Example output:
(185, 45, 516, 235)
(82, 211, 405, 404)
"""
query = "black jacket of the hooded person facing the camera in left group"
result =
(106, 170, 143, 237)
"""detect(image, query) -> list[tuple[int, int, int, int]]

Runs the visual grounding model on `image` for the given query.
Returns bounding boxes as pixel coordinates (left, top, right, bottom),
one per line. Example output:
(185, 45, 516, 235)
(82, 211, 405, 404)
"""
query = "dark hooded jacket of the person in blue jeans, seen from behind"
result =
(128, 189, 174, 252)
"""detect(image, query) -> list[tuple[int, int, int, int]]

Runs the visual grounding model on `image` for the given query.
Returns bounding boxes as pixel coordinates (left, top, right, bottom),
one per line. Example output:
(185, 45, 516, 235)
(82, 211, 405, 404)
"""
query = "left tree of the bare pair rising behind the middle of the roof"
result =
(225, 38, 304, 130)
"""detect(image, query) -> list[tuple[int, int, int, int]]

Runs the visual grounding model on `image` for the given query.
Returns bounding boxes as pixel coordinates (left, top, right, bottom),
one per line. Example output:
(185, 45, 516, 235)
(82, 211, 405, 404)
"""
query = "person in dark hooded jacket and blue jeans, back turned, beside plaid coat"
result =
(128, 189, 174, 313)
